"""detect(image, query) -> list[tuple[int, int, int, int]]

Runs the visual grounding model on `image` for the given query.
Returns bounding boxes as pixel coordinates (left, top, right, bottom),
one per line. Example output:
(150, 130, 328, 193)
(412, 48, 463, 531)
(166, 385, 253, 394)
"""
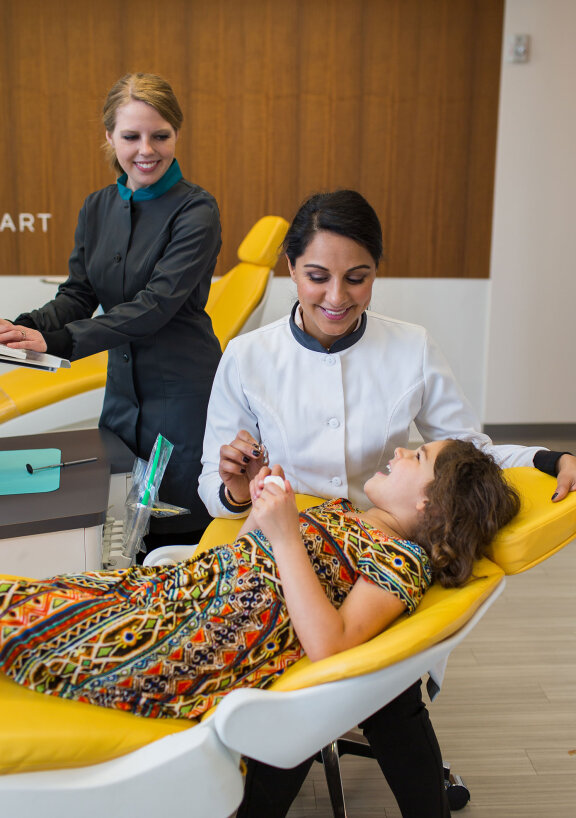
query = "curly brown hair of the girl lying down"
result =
(414, 440, 520, 588)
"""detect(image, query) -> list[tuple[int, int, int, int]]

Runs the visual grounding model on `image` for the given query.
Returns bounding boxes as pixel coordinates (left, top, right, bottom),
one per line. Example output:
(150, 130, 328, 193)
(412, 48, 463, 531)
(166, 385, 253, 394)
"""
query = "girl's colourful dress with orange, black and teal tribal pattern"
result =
(0, 500, 431, 718)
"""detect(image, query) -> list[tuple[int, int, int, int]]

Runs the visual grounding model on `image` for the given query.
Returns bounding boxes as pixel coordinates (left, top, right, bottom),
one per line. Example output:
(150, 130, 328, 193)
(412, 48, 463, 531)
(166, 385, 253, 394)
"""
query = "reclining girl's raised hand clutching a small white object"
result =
(251, 466, 302, 550)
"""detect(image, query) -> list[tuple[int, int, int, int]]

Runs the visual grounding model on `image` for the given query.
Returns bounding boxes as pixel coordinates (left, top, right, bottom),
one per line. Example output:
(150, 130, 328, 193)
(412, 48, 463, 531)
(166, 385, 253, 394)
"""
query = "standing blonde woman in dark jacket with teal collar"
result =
(0, 74, 221, 542)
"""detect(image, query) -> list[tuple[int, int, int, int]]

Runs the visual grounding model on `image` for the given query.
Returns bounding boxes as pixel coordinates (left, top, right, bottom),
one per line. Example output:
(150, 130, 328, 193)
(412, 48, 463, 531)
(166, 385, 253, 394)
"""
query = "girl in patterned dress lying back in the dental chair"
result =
(0, 440, 519, 718)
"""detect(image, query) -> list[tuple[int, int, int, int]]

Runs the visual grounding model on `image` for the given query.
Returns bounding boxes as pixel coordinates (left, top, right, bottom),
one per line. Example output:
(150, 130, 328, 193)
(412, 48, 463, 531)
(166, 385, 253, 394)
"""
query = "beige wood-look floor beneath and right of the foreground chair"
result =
(290, 430, 576, 818)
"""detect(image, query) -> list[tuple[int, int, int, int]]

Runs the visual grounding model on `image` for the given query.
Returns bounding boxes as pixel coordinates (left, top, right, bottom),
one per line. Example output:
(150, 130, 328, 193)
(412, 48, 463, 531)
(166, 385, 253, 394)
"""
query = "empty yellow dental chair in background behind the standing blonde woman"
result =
(0, 216, 288, 437)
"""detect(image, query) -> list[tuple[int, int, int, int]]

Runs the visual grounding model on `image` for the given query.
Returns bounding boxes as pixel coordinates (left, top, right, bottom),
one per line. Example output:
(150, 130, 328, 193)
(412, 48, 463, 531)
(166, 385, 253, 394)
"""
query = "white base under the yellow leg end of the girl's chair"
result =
(0, 720, 243, 818)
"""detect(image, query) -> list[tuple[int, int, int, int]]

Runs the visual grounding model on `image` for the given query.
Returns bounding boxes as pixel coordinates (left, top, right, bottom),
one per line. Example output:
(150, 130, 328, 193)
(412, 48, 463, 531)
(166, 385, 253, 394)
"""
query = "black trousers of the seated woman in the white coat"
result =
(237, 681, 450, 818)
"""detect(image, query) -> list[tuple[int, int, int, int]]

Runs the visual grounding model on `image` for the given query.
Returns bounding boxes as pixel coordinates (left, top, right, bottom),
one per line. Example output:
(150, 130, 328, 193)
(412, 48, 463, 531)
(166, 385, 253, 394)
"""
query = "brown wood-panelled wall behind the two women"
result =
(0, 0, 503, 278)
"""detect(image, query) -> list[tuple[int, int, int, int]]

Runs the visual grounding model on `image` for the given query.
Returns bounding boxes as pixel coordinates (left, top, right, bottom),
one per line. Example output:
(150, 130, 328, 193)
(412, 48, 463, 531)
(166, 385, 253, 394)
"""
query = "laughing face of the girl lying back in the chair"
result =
(364, 440, 446, 513)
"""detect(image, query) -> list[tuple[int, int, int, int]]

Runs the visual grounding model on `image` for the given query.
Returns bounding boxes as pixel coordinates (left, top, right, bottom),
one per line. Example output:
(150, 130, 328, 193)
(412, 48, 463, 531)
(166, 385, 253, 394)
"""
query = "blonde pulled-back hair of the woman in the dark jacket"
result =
(102, 73, 184, 174)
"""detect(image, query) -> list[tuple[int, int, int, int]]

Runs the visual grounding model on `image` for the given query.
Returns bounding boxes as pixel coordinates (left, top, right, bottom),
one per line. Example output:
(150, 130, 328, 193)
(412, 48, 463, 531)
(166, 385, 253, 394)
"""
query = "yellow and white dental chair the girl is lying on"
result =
(0, 468, 576, 818)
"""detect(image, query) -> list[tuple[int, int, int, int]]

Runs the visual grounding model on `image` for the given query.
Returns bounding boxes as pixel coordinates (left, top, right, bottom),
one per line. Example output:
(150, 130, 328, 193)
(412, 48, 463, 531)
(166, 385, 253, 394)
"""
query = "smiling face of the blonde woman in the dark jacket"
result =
(106, 100, 178, 190)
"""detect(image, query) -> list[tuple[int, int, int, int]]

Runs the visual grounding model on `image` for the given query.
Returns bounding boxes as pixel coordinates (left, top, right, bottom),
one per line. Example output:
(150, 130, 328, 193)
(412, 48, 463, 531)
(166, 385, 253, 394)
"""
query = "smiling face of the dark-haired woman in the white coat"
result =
(288, 231, 376, 349)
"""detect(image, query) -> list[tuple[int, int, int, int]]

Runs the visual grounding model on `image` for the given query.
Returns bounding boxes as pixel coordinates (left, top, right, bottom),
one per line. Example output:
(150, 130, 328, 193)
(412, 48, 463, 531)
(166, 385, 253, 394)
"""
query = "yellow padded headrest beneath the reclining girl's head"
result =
(489, 467, 576, 574)
